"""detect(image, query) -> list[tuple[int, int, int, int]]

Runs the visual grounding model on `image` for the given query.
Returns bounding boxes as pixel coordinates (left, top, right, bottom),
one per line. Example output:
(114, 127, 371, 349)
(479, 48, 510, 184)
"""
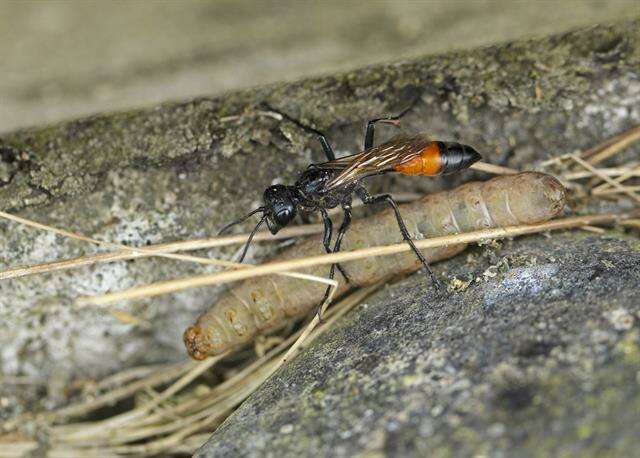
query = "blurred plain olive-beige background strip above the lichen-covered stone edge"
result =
(0, 0, 640, 132)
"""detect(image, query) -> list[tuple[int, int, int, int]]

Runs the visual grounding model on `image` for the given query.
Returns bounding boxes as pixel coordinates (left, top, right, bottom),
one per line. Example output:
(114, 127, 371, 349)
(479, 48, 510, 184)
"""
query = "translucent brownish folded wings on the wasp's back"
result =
(316, 135, 431, 190)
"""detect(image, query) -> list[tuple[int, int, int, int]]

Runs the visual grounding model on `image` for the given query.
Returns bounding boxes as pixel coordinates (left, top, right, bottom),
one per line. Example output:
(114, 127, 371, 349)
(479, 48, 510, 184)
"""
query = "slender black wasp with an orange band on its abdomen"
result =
(219, 107, 482, 303)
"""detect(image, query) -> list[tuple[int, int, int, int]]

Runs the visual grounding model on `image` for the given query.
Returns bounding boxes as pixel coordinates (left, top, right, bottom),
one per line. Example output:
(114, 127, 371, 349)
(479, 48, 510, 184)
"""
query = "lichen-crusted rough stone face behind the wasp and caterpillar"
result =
(0, 20, 640, 398)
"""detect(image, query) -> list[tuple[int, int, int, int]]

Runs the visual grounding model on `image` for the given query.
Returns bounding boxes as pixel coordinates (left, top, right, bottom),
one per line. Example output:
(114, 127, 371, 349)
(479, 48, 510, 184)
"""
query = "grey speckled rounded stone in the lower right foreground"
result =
(196, 232, 640, 458)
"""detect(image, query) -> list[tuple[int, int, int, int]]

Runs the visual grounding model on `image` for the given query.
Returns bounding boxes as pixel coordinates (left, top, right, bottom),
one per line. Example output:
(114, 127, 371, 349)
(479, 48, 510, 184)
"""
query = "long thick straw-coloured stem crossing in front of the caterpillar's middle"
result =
(78, 214, 624, 305)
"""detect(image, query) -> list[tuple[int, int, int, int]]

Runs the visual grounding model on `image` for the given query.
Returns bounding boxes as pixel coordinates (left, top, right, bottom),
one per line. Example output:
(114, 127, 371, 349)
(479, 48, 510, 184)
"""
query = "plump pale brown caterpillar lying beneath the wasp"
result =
(183, 172, 565, 360)
